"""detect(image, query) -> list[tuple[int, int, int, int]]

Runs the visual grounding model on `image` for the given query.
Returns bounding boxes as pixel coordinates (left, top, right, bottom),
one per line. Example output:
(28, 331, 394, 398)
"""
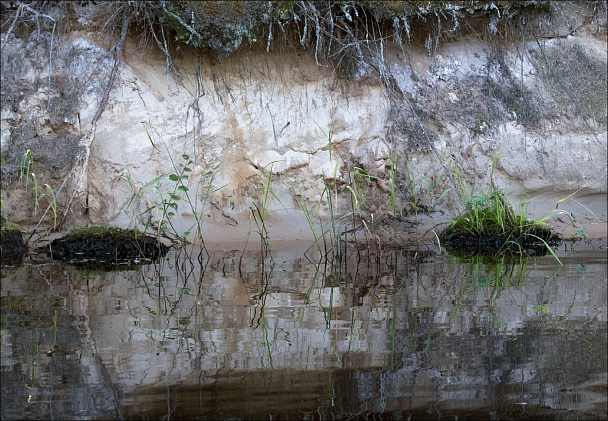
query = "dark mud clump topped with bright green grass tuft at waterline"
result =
(439, 191, 562, 256)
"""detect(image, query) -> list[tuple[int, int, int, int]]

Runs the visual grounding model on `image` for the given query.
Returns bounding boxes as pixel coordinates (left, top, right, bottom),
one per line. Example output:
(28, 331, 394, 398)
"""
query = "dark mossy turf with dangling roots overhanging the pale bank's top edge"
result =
(159, 0, 551, 56)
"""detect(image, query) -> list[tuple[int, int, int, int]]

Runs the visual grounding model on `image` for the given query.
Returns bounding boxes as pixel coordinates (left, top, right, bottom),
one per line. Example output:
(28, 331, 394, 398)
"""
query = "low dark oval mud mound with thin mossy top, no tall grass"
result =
(37, 227, 168, 265)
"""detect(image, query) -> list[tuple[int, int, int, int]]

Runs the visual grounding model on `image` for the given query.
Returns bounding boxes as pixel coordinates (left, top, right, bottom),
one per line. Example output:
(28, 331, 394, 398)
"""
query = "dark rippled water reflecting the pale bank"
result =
(1, 238, 608, 420)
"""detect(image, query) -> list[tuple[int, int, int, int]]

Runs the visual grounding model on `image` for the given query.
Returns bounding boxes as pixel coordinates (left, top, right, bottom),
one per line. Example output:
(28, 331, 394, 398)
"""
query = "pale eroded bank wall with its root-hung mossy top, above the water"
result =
(1, 1, 607, 243)
